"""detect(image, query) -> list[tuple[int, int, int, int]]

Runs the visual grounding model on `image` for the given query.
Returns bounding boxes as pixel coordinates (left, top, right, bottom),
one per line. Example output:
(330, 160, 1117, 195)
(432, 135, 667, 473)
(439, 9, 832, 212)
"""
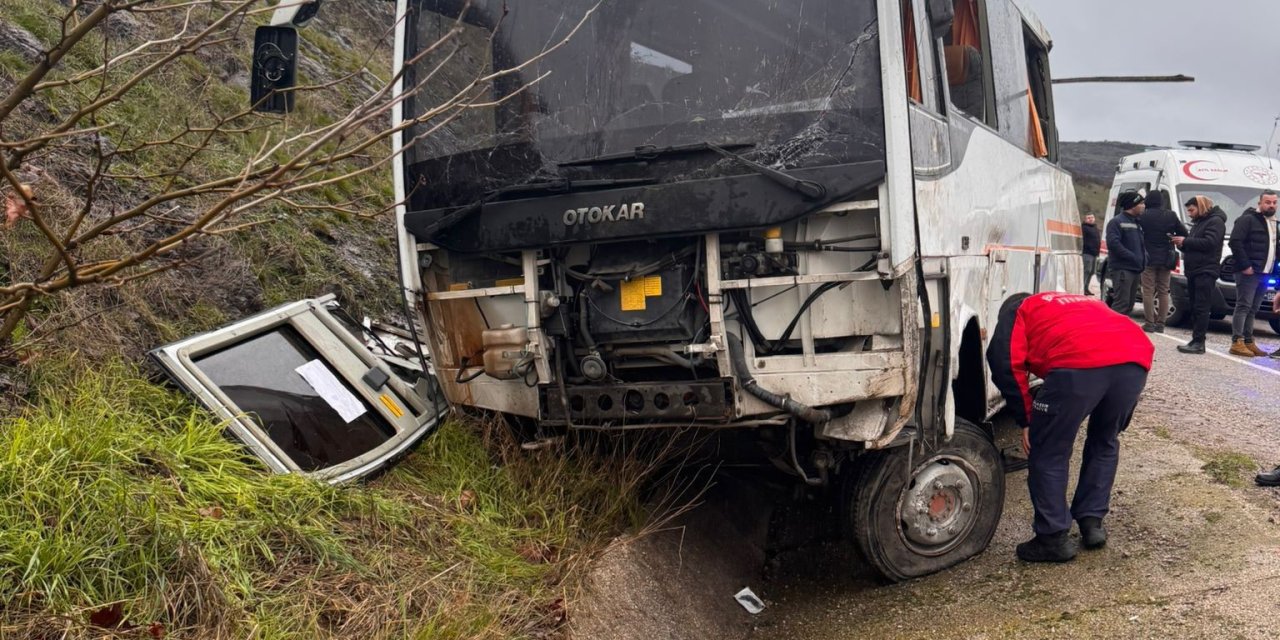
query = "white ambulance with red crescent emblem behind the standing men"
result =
(1100, 141, 1280, 333)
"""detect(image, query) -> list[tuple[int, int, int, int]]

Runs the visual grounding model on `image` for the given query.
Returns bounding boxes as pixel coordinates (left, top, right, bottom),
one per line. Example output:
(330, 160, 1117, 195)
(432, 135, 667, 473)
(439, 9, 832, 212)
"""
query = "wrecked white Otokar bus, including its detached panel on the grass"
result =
(161, 0, 1083, 580)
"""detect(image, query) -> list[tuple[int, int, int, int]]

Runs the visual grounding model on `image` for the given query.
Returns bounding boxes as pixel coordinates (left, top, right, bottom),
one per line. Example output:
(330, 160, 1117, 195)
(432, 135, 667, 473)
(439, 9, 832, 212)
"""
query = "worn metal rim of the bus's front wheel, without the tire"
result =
(897, 457, 979, 556)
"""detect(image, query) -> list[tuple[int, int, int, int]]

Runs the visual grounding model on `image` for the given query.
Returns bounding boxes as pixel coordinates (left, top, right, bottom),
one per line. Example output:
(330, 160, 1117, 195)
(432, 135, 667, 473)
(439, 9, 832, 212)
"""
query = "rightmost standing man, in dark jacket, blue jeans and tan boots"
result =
(1230, 189, 1276, 357)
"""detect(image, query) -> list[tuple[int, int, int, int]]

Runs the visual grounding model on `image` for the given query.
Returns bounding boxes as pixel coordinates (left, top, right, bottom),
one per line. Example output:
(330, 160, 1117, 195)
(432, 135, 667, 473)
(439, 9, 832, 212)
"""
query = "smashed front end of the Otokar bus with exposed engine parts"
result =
(399, 0, 920, 448)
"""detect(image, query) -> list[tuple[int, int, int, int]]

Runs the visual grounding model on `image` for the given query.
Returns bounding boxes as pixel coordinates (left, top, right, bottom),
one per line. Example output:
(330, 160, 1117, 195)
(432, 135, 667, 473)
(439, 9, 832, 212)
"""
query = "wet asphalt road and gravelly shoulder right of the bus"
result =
(750, 307, 1280, 640)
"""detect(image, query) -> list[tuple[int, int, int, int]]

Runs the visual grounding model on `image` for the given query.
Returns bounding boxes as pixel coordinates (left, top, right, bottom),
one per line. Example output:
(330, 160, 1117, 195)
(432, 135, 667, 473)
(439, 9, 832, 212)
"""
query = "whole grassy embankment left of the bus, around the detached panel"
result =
(0, 0, 649, 639)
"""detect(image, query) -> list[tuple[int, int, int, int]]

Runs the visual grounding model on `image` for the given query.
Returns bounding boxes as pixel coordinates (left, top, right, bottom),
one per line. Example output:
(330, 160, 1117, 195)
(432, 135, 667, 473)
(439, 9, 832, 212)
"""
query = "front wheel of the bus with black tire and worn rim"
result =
(842, 417, 1005, 582)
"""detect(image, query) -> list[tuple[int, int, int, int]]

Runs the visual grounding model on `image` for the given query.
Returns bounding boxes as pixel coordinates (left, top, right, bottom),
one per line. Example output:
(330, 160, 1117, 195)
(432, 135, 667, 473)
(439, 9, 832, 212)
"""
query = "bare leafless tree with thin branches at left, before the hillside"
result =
(0, 0, 585, 346)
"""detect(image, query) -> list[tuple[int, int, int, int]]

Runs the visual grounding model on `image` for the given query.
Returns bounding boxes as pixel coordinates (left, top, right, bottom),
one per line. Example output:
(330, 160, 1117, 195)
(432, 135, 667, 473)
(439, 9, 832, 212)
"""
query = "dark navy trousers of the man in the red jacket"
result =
(1027, 365, 1147, 535)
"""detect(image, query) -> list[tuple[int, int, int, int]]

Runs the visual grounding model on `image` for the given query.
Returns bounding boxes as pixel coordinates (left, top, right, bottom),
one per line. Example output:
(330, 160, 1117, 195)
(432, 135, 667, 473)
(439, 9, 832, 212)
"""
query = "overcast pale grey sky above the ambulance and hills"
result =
(1024, 0, 1280, 155)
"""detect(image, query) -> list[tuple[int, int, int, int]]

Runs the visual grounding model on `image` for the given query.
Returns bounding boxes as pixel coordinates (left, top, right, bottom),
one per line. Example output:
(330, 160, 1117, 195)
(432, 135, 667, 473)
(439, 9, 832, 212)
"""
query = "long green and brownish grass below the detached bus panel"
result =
(0, 362, 652, 639)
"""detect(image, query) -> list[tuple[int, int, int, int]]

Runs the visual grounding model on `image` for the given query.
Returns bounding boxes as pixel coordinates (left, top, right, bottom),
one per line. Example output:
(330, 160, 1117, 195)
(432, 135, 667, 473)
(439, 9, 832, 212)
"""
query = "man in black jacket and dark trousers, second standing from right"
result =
(1172, 196, 1226, 353)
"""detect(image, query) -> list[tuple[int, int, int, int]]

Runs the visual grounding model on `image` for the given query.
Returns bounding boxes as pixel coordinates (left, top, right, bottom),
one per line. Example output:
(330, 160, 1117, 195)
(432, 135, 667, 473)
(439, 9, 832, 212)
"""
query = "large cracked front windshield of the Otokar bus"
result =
(404, 0, 884, 210)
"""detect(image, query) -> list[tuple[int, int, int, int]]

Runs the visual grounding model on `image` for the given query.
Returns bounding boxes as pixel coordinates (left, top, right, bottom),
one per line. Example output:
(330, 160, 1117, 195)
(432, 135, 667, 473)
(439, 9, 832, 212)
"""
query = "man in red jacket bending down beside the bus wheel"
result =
(987, 292, 1155, 562)
